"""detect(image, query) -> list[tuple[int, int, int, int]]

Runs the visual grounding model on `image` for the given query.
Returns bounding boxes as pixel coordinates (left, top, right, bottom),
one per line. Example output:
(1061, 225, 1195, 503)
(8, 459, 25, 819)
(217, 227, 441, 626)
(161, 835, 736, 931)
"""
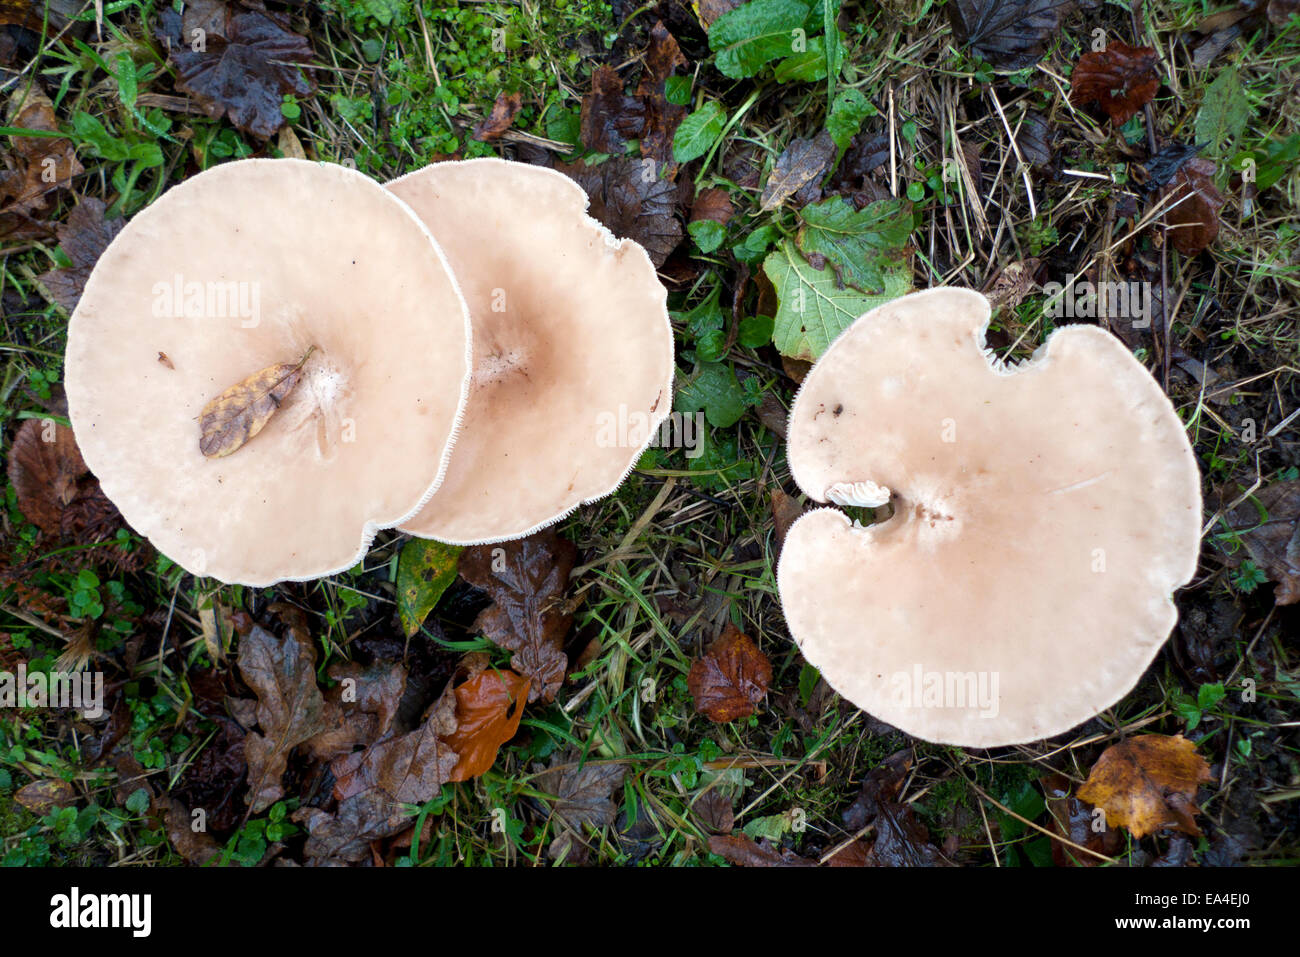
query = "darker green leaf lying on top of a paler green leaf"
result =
(798, 196, 911, 293)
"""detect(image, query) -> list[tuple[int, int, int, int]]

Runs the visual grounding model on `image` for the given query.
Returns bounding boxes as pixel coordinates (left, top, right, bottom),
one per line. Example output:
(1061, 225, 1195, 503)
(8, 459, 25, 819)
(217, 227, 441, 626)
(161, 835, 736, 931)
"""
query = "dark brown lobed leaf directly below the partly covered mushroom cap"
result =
(460, 528, 577, 701)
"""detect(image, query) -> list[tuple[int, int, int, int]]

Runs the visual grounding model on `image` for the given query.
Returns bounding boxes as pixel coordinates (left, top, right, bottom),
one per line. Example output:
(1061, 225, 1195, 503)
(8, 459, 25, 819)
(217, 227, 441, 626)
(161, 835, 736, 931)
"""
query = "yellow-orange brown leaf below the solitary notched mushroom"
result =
(1078, 735, 1213, 837)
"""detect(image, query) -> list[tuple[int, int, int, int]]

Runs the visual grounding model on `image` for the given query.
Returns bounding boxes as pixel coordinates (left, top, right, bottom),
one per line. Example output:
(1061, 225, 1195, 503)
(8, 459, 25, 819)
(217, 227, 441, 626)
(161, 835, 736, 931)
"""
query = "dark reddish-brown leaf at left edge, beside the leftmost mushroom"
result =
(8, 419, 125, 557)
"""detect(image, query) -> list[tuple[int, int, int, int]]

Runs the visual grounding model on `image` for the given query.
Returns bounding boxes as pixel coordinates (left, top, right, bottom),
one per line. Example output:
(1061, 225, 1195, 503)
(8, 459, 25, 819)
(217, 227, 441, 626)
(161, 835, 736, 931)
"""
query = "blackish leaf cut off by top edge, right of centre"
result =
(948, 0, 1075, 70)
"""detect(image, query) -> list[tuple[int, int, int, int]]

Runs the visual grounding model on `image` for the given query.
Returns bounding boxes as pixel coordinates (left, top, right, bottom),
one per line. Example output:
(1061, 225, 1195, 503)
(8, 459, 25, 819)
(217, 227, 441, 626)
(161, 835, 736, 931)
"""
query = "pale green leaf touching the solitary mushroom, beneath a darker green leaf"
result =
(763, 239, 911, 361)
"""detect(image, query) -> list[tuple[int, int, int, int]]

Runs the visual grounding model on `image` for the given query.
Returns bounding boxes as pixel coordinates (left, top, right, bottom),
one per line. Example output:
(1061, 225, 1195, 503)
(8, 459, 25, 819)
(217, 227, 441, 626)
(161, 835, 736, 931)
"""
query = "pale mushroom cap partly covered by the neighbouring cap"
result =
(389, 159, 673, 545)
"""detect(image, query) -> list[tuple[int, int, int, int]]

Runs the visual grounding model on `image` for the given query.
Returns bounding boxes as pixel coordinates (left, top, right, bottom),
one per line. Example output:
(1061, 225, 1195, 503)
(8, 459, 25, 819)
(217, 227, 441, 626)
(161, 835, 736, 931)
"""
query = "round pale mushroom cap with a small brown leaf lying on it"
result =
(66, 160, 471, 585)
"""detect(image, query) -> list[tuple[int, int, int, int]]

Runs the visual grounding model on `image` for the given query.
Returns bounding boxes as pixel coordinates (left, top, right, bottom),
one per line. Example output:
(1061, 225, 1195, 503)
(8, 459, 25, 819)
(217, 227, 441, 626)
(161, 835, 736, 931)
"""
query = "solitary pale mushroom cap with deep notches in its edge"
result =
(777, 289, 1201, 748)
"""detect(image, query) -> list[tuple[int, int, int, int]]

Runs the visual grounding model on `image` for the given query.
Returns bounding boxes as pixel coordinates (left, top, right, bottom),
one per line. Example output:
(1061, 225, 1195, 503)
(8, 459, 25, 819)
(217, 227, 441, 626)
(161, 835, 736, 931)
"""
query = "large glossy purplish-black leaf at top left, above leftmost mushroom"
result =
(157, 0, 313, 139)
